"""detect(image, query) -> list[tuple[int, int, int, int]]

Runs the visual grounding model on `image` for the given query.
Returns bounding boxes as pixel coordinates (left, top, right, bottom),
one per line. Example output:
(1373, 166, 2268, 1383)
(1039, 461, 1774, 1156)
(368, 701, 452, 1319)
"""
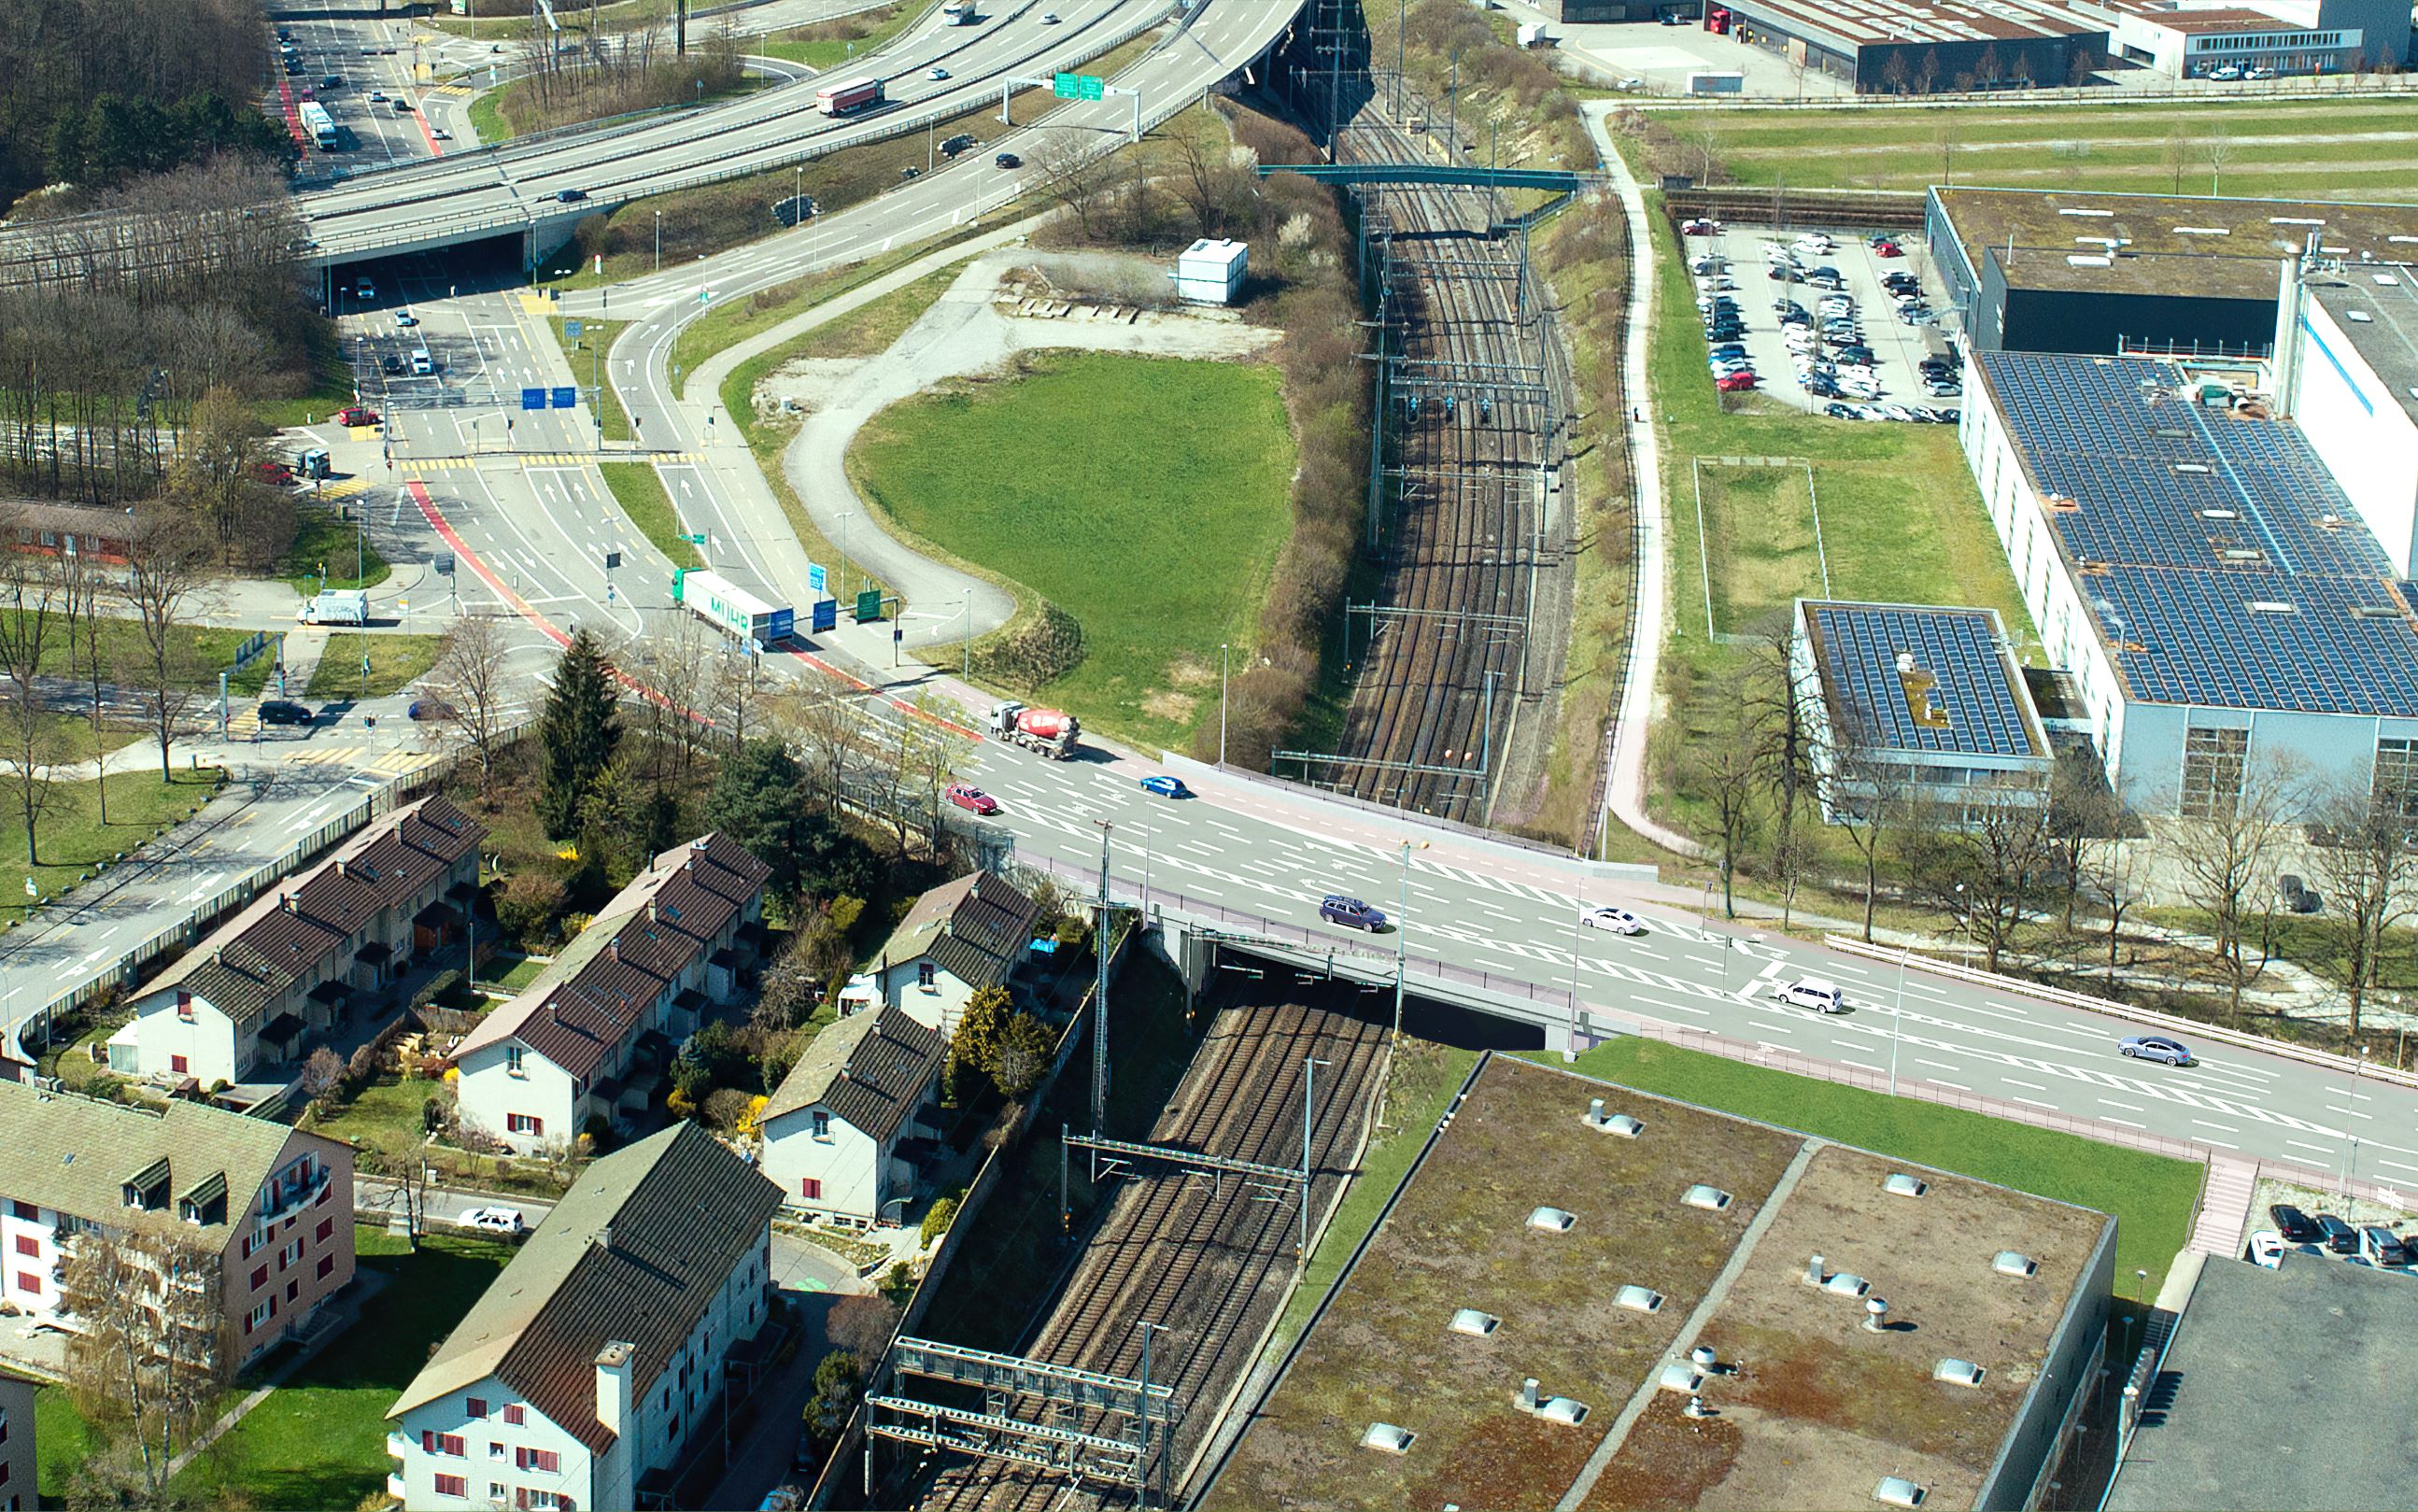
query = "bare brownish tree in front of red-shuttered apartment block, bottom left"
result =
(61, 1212, 233, 1507)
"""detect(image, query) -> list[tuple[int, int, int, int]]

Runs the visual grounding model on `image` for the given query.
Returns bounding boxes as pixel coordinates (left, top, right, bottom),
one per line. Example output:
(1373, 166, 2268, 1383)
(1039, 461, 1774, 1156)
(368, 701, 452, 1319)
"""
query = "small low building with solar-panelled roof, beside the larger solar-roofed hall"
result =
(1789, 598, 2053, 825)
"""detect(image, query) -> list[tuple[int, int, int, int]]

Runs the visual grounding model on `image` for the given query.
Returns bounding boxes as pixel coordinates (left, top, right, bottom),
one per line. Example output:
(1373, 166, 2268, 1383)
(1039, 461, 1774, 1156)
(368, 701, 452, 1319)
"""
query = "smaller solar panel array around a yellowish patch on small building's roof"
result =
(1806, 602, 2048, 757)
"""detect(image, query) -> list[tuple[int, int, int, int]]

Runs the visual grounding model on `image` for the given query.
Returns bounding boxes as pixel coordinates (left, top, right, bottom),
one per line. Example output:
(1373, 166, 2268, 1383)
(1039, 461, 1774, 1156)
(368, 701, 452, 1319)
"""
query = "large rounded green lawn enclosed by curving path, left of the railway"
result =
(849, 353, 1294, 745)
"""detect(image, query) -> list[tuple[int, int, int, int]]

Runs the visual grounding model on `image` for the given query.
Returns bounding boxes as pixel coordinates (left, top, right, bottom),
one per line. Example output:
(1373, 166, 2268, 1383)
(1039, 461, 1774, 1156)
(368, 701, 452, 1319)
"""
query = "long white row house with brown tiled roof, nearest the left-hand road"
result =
(109, 796, 486, 1086)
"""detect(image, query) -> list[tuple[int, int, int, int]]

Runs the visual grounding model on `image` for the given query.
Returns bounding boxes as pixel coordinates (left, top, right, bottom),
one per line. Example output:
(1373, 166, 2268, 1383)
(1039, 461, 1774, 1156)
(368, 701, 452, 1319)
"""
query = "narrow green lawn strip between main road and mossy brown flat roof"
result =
(1531, 1038, 2203, 1296)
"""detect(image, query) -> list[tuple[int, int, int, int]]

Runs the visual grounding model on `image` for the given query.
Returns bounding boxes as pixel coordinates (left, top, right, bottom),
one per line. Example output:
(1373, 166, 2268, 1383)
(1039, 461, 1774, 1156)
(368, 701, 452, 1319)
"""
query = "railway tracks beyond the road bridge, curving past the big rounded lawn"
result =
(1330, 91, 1560, 823)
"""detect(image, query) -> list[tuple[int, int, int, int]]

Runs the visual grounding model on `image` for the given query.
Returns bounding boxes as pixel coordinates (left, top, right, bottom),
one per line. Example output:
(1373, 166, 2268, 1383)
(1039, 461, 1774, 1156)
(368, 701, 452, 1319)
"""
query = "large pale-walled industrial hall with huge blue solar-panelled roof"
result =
(1961, 351, 2418, 815)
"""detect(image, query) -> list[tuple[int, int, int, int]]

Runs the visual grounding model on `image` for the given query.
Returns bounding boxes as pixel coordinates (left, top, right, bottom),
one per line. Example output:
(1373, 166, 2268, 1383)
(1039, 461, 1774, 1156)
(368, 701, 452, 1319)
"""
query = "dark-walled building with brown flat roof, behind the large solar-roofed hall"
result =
(1925, 189, 2418, 358)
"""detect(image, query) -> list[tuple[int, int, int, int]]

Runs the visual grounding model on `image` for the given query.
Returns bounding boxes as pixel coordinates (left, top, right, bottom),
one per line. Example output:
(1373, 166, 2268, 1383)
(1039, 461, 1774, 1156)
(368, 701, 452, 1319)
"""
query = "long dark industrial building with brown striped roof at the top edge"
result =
(1702, 0, 2109, 94)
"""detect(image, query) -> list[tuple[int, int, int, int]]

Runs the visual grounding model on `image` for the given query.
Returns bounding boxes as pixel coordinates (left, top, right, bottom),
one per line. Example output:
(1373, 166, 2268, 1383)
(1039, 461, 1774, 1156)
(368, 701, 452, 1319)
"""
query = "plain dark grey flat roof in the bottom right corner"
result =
(2103, 1251, 2418, 1512)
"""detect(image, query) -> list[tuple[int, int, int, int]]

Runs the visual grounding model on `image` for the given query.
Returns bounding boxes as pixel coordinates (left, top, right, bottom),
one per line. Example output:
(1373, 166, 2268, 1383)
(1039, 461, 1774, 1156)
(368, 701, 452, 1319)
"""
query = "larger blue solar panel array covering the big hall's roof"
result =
(1975, 351, 2418, 716)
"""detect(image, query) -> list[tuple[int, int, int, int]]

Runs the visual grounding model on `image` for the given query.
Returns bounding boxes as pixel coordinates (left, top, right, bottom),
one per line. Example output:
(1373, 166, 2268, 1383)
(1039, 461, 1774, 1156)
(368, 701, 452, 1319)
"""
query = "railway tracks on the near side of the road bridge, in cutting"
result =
(921, 1007, 1383, 1512)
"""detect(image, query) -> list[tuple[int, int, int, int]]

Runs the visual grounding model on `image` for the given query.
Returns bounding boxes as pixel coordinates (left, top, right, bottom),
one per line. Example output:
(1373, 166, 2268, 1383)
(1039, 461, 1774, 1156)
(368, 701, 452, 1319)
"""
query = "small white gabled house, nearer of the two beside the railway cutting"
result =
(757, 1004, 948, 1224)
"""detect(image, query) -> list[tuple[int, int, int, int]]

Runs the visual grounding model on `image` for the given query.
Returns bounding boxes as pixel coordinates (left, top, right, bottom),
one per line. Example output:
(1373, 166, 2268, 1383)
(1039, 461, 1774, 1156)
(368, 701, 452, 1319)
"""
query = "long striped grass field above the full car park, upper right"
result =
(1659, 92, 2418, 201)
